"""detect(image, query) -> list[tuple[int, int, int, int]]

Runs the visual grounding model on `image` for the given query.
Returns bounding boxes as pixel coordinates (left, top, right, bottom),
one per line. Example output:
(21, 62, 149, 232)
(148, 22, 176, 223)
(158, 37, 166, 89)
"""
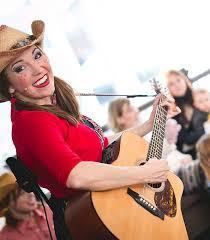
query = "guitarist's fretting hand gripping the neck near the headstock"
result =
(149, 94, 181, 126)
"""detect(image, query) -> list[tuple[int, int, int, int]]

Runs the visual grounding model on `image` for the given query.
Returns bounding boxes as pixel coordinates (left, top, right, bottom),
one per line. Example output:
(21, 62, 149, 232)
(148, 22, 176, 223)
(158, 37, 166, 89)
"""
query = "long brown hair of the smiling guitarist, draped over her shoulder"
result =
(0, 71, 81, 125)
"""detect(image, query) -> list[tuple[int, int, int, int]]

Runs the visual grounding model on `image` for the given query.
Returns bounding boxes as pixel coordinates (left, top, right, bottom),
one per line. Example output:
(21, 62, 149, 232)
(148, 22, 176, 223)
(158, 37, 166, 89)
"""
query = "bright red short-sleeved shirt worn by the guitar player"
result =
(12, 110, 108, 198)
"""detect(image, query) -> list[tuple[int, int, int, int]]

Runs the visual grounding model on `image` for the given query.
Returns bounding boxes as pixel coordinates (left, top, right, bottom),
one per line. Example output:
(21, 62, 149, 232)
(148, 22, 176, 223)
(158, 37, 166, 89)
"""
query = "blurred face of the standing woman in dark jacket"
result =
(167, 74, 187, 97)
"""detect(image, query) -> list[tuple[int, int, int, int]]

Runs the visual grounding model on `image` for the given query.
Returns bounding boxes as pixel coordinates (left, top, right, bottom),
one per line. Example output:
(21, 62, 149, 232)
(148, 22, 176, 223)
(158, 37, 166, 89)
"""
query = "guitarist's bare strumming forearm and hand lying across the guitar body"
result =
(66, 159, 169, 191)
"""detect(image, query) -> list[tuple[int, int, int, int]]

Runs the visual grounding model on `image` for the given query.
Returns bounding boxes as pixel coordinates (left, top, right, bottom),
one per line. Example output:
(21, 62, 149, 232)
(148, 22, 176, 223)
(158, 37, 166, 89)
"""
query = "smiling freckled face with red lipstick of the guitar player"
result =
(6, 46, 55, 105)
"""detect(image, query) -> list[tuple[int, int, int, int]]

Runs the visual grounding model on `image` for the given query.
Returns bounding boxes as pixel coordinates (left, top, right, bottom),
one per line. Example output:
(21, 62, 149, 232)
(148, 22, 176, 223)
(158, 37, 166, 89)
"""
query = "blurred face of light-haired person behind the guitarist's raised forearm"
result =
(119, 103, 139, 129)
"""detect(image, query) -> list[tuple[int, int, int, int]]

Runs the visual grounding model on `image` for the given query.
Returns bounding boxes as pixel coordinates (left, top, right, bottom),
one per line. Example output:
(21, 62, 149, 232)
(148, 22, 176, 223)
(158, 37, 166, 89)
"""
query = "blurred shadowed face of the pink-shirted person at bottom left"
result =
(13, 190, 37, 213)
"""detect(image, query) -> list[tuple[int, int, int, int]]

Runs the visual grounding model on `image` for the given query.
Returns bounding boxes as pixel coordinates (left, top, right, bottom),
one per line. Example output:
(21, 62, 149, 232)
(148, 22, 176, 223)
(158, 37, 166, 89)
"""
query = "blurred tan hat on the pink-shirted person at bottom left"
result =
(0, 173, 18, 217)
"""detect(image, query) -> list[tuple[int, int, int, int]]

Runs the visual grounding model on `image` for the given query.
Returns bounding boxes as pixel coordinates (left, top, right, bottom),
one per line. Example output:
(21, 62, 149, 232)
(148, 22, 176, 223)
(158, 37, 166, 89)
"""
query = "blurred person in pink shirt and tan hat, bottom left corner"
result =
(0, 173, 55, 240)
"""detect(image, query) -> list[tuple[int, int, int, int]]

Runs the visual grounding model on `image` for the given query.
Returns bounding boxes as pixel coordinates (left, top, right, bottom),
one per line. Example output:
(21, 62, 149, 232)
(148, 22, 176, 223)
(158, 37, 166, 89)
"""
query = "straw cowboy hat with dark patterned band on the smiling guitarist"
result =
(0, 20, 45, 101)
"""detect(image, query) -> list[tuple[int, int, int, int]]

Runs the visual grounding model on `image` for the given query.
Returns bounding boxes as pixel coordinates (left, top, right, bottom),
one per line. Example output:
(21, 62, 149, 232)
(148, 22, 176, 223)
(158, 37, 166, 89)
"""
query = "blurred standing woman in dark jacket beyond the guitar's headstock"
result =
(166, 70, 207, 159)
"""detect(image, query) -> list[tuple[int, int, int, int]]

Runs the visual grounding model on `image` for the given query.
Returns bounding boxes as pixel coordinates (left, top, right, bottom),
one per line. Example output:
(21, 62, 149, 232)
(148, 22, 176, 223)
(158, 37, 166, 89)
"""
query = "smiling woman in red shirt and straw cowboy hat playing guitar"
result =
(0, 21, 180, 239)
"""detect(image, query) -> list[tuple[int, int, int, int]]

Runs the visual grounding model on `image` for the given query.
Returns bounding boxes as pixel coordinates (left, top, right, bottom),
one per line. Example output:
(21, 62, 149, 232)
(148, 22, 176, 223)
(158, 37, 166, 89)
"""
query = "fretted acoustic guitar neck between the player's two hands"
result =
(146, 96, 167, 161)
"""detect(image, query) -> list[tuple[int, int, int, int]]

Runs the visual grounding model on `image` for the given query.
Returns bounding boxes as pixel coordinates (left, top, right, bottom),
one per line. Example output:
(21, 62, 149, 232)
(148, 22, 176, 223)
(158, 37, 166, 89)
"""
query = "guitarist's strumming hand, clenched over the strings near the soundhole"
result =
(140, 158, 169, 183)
